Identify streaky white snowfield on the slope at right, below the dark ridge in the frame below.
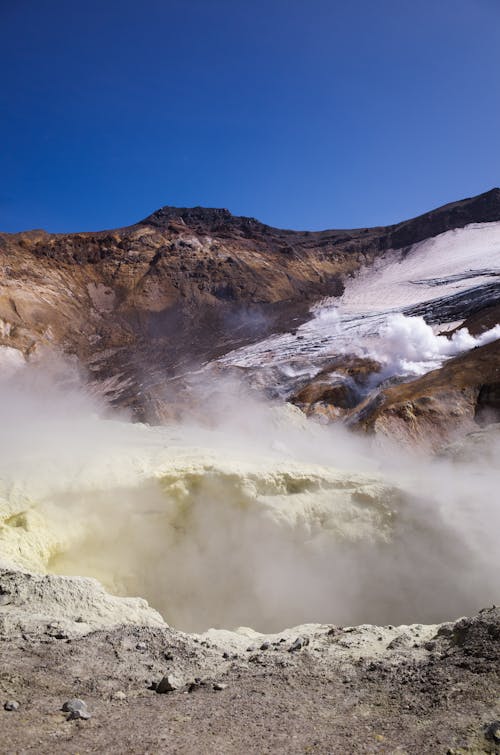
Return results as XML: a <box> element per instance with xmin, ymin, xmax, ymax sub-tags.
<box><xmin>211</xmin><ymin>222</ymin><xmax>500</xmax><ymax>378</ymax></box>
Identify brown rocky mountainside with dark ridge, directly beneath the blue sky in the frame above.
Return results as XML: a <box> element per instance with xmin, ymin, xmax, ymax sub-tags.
<box><xmin>0</xmin><ymin>189</ymin><xmax>500</xmax><ymax>420</ymax></box>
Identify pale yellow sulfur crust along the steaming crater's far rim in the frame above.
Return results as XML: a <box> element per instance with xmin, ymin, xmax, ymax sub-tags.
<box><xmin>0</xmin><ymin>449</ymin><xmax>398</xmax><ymax>573</ymax></box>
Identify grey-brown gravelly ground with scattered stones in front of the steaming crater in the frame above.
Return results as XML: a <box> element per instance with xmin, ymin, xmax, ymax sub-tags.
<box><xmin>0</xmin><ymin>568</ymin><xmax>500</xmax><ymax>755</ymax></box>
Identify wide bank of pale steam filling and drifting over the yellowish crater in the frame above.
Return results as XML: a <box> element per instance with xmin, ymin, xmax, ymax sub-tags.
<box><xmin>0</xmin><ymin>364</ymin><xmax>500</xmax><ymax>632</ymax></box>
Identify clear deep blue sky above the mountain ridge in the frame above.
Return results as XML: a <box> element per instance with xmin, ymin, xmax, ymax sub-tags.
<box><xmin>0</xmin><ymin>0</ymin><xmax>500</xmax><ymax>231</ymax></box>
